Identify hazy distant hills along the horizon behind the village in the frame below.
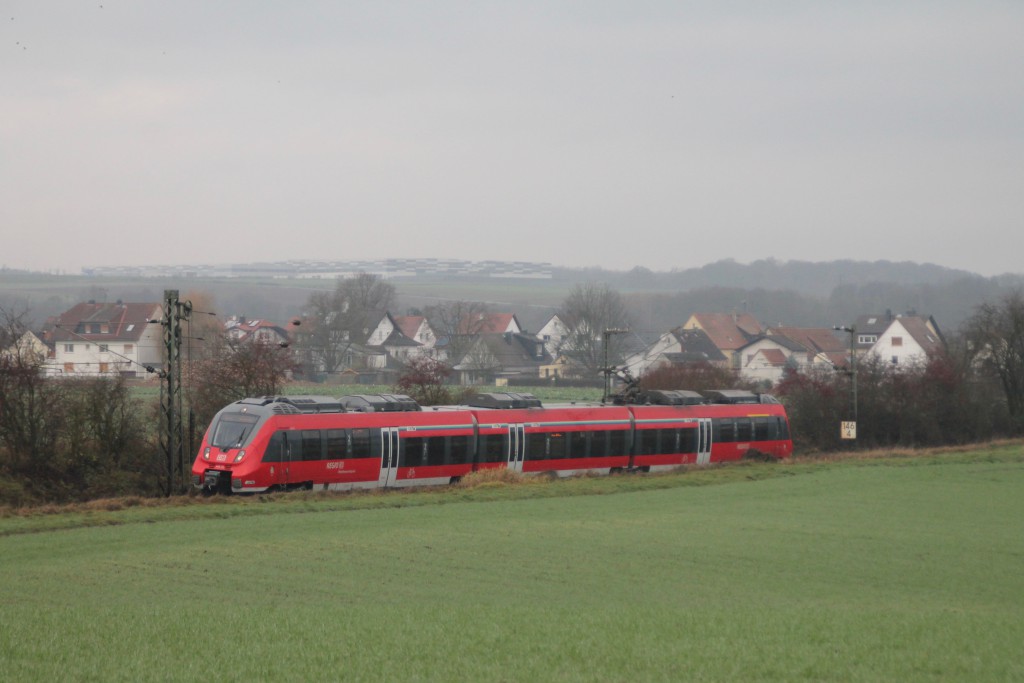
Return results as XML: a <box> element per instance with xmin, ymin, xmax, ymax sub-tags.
<box><xmin>0</xmin><ymin>259</ymin><xmax>1024</xmax><ymax>332</ymax></box>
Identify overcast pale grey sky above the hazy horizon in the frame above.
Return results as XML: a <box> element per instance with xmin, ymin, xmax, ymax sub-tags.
<box><xmin>6</xmin><ymin>0</ymin><xmax>1024</xmax><ymax>275</ymax></box>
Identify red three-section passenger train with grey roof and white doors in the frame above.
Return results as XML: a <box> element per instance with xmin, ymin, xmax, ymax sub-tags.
<box><xmin>193</xmin><ymin>391</ymin><xmax>793</xmax><ymax>493</ymax></box>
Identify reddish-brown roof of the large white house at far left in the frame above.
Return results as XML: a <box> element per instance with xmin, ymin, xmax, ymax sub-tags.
<box><xmin>52</xmin><ymin>302</ymin><xmax>163</xmax><ymax>344</ymax></box>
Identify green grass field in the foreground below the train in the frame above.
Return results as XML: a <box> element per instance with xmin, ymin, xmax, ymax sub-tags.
<box><xmin>0</xmin><ymin>443</ymin><xmax>1024</xmax><ymax>681</ymax></box>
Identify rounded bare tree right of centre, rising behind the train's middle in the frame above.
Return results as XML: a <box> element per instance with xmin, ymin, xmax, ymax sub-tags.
<box><xmin>558</xmin><ymin>283</ymin><xmax>630</xmax><ymax>375</ymax></box>
